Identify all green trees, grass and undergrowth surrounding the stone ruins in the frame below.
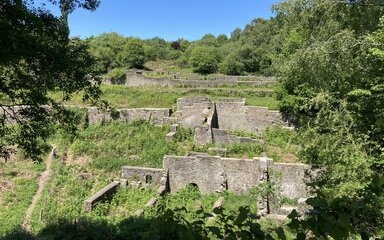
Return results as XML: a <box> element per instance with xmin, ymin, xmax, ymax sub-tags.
<box><xmin>0</xmin><ymin>0</ymin><xmax>384</xmax><ymax>239</ymax></box>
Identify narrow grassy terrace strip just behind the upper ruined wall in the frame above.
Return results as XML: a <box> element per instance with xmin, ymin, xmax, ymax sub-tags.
<box><xmin>50</xmin><ymin>85</ymin><xmax>278</xmax><ymax>109</ymax></box>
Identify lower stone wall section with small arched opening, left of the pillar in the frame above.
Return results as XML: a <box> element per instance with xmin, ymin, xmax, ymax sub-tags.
<box><xmin>163</xmin><ymin>156</ymin><xmax>259</xmax><ymax>193</ymax></box>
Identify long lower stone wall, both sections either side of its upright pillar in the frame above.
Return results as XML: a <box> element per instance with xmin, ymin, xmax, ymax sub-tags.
<box><xmin>163</xmin><ymin>155</ymin><xmax>310</xmax><ymax>200</ymax></box>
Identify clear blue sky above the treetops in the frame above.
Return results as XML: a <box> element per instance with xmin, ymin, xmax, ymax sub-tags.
<box><xmin>35</xmin><ymin>0</ymin><xmax>279</xmax><ymax>40</ymax></box>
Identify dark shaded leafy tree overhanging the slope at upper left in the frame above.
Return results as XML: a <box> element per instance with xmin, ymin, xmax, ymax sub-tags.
<box><xmin>0</xmin><ymin>0</ymin><xmax>101</xmax><ymax>160</ymax></box>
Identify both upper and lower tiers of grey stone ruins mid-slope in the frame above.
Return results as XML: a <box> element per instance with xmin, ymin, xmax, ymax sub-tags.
<box><xmin>83</xmin><ymin>97</ymin><xmax>310</xmax><ymax>215</ymax></box>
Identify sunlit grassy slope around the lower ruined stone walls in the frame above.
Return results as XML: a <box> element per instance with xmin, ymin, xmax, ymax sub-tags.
<box><xmin>0</xmin><ymin>122</ymin><xmax>294</xmax><ymax>238</ymax></box>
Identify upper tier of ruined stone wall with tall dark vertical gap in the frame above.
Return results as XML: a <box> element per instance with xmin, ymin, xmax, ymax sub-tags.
<box><xmin>88</xmin><ymin>97</ymin><xmax>290</xmax><ymax>145</ymax></box>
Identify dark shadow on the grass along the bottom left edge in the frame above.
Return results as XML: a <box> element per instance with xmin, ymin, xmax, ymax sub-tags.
<box><xmin>0</xmin><ymin>216</ymin><xmax>207</xmax><ymax>240</ymax></box>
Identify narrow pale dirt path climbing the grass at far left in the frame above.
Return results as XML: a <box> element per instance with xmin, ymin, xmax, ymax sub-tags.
<box><xmin>22</xmin><ymin>145</ymin><xmax>56</xmax><ymax>232</ymax></box>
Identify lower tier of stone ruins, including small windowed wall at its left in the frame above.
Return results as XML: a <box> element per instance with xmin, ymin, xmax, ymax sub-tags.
<box><xmin>122</xmin><ymin>154</ymin><xmax>310</xmax><ymax>214</ymax></box>
